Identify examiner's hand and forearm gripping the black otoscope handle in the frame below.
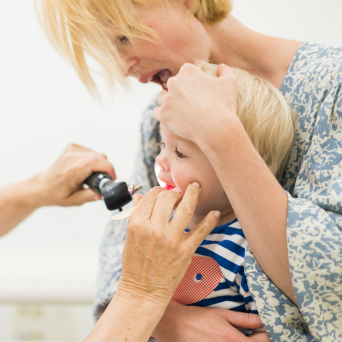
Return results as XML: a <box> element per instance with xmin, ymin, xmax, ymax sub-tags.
<box><xmin>0</xmin><ymin>145</ymin><xmax>115</xmax><ymax>236</ymax></box>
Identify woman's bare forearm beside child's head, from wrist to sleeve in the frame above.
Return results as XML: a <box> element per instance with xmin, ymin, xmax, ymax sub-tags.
<box><xmin>199</xmin><ymin>122</ymin><xmax>295</xmax><ymax>303</ymax></box>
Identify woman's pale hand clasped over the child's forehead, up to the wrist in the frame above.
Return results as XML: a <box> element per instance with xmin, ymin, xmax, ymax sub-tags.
<box><xmin>153</xmin><ymin>64</ymin><xmax>239</xmax><ymax>145</ymax></box>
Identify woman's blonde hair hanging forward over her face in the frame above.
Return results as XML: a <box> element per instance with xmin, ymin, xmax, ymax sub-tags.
<box><xmin>36</xmin><ymin>0</ymin><xmax>232</xmax><ymax>94</ymax></box>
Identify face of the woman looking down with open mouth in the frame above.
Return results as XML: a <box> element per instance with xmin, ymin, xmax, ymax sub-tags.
<box><xmin>116</xmin><ymin>0</ymin><xmax>211</xmax><ymax>88</ymax></box>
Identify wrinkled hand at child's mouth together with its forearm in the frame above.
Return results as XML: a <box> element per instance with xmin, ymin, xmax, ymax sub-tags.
<box><xmin>86</xmin><ymin>183</ymin><xmax>219</xmax><ymax>342</ymax></box>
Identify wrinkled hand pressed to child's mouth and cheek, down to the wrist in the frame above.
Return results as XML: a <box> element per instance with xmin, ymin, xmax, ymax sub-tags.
<box><xmin>116</xmin><ymin>183</ymin><xmax>219</xmax><ymax>308</ymax></box>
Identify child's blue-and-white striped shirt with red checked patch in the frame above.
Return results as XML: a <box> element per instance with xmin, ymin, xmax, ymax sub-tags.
<box><xmin>172</xmin><ymin>219</ymin><xmax>258</xmax><ymax>314</ymax></box>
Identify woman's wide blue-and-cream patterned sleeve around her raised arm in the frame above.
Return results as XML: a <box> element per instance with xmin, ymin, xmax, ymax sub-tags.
<box><xmin>287</xmin><ymin>195</ymin><xmax>342</xmax><ymax>341</ymax></box>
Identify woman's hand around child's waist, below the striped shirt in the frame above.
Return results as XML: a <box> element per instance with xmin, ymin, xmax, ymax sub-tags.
<box><xmin>152</xmin><ymin>300</ymin><xmax>267</xmax><ymax>342</ymax></box>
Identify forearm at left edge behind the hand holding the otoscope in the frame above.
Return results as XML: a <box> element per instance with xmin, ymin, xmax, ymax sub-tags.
<box><xmin>0</xmin><ymin>175</ymin><xmax>41</xmax><ymax>236</ymax></box>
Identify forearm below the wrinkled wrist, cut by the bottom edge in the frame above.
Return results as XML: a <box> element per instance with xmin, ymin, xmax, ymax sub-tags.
<box><xmin>85</xmin><ymin>290</ymin><xmax>167</xmax><ymax>342</ymax></box>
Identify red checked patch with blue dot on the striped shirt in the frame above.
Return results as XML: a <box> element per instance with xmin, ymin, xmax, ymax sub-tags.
<box><xmin>172</xmin><ymin>256</ymin><xmax>223</xmax><ymax>305</ymax></box>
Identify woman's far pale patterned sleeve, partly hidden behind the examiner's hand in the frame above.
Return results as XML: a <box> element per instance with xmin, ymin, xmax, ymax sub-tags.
<box><xmin>95</xmin><ymin>101</ymin><xmax>160</xmax><ymax>319</ymax></box>
